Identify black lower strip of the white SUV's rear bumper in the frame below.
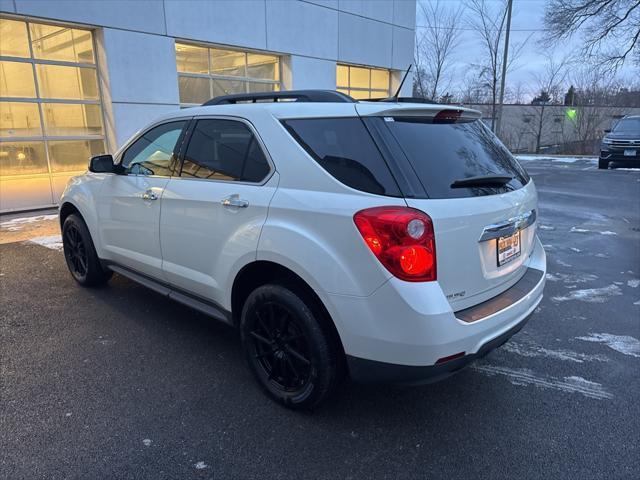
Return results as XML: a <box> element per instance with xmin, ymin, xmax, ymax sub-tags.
<box><xmin>347</xmin><ymin>315</ymin><xmax>532</xmax><ymax>385</ymax></box>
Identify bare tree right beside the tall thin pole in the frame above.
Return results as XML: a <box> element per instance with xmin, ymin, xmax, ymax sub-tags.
<box><xmin>466</xmin><ymin>0</ymin><xmax>528</xmax><ymax>131</ymax></box>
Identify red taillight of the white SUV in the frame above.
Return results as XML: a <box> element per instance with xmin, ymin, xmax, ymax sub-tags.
<box><xmin>353</xmin><ymin>207</ymin><xmax>437</xmax><ymax>282</ymax></box>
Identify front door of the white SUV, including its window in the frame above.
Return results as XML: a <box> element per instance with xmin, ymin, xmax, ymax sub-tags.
<box><xmin>98</xmin><ymin>120</ymin><xmax>187</xmax><ymax>279</ymax></box>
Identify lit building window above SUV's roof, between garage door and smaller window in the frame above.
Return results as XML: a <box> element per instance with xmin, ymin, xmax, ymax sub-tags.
<box><xmin>176</xmin><ymin>43</ymin><xmax>280</xmax><ymax>107</ymax></box>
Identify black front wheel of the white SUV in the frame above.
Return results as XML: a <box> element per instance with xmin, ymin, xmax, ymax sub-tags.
<box><xmin>62</xmin><ymin>214</ymin><xmax>113</xmax><ymax>287</ymax></box>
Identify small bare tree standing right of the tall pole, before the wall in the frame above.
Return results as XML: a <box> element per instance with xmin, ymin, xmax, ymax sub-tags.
<box><xmin>527</xmin><ymin>54</ymin><xmax>570</xmax><ymax>153</ymax></box>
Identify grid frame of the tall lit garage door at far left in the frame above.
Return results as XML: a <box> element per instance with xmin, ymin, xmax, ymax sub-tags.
<box><xmin>0</xmin><ymin>13</ymin><xmax>109</xmax><ymax>180</ymax></box>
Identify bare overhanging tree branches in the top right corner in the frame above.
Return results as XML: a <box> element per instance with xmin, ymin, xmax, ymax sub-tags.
<box><xmin>544</xmin><ymin>0</ymin><xmax>640</xmax><ymax>68</ymax></box>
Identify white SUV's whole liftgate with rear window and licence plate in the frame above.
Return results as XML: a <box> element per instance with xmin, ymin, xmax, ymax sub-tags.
<box><xmin>367</xmin><ymin>111</ymin><xmax>537</xmax><ymax>310</ymax></box>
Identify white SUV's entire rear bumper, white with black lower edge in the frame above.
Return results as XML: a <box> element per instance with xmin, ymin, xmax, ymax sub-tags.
<box><xmin>327</xmin><ymin>239</ymin><xmax>546</xmax><ymax>376</ymax></box>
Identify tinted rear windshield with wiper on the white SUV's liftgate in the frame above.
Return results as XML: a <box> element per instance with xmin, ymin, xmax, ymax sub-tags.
<box><xmin>380</xmin><ymin>117</ymin><xmax>529</xmax><ymax>198</ymax></box>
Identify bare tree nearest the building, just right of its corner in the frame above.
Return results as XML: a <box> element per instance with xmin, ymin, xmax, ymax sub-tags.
<box><xmin>416</xmin><ymin>0</ymin><xmax>463</xmax><ymax>100</ymax></box>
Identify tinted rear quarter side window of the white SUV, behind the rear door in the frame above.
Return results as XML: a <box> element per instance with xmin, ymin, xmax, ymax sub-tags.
<box><xmin>284</xmin><ymin>118</ymin><xmax>401</xmax><ymax>197</ymax></box>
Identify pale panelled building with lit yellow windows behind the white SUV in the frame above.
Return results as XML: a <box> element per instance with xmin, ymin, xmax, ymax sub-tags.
<box><xmin>0</xmin><ymin>0</ymin><xmax>416</xmax><ymax>212</ymax></box>
